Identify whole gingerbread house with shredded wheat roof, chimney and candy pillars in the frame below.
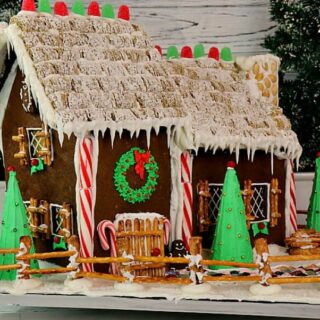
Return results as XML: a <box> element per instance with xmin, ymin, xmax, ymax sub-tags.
<box><xmin>1</xmin><ymin>8</ymin><xmax>301</xmax><ymax>268</ymax></box>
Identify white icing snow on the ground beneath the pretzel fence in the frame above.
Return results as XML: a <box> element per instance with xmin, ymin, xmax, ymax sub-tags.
<box><xmin>0</xmin><ymin>246</ymin><xmax>320</xmax><ymax>304</ymax></box>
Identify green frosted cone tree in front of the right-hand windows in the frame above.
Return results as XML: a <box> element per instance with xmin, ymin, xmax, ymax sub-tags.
<box><xmin>210</xmin><ymin>161</ymin><xmax>253</xmax><ymax>270</ymax></box>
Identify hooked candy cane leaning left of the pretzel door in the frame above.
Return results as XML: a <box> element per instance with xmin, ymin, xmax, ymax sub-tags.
<box><xmin>97</xmin><ymin>220</ymin><xmax>118</xmax><ymax>274</ymax></box>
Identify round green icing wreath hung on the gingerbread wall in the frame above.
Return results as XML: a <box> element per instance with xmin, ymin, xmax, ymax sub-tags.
<box><xmin>113</xmin><ymin>147</ymin><xmax>159</xmax><ymax>204</ymax></box>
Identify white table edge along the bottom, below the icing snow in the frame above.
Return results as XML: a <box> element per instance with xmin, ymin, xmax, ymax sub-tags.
<box><xmin>0</xmin><ymin>294</ymin><xmax>320</xmax><ymax>320</ymax></box>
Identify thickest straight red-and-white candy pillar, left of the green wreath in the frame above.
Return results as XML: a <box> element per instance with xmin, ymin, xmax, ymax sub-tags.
<box><xmin>79</xmin><ymin>137</ymin><xmax>94</xmax><ymax>272</ymax></box>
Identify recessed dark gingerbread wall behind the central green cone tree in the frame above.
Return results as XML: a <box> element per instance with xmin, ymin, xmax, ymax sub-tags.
<box><xmin>192</xmin><ymin>150</ymin><xmax>286</xmax><ymax>248</ymax></box>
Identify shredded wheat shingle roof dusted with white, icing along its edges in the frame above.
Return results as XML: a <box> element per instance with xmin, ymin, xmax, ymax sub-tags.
<box><xmin>8</xmin><ymin>14</ymin><xmax>301</xmax><ymax>158</ymax></box>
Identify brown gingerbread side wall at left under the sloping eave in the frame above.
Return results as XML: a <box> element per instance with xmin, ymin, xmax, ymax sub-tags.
<box><xmin>2</xmin><ymin>72</ymin><xmax>76</xmax><ymax>255</ymax></box>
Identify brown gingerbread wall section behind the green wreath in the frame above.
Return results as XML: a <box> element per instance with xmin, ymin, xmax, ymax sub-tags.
<box><xmin>95</xmin><ymin>130</ymin><xmax>171</xmax><ymax>271</ymax></box>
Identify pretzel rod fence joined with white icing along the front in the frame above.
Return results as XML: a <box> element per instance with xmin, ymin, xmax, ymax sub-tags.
<box><xmin>0</xmin><ymin>236</ymin><xmax>320</xmax><ymax>285</ymax></box>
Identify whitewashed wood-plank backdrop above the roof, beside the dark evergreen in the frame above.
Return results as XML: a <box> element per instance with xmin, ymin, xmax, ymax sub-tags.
<box><xmin>66</xmin><ymin>0</ymin><xmax>274</xmax><ymax>55</ymax></box>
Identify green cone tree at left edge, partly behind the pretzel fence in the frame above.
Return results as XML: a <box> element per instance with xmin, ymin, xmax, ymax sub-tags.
<box><xmin>0</xmin><ymin>168</ymin><xmax>39</xmax><ymax>280</ymax></box>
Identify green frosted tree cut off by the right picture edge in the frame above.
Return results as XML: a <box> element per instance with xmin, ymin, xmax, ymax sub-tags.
<box><xmin>307</xmin><ymin>152</ymin><xmax>320</xmax><ymax>232</ymax></box>
